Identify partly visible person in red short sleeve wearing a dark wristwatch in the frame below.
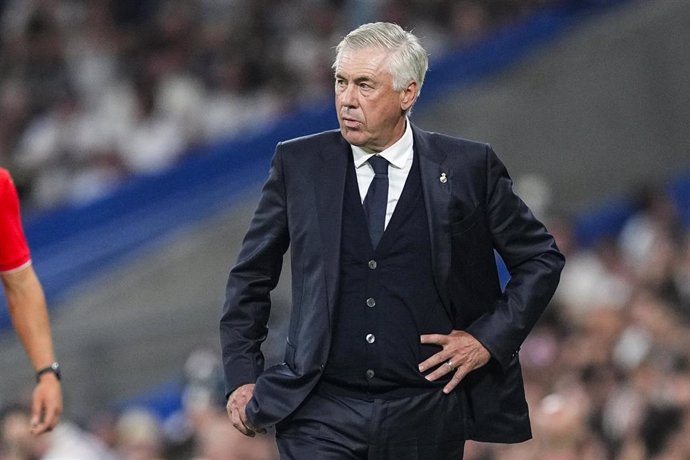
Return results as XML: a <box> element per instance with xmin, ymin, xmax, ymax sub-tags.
<box><xmin>0</xmin><ymin>168</ymin><xmax>62</xmax><ymax>434</ymax></box>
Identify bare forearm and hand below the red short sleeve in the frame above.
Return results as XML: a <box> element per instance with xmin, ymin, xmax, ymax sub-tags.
<box><xmin>0</xmin><ymin>265</ymin><xmax>62</xmax><ymax>434</ymax></box>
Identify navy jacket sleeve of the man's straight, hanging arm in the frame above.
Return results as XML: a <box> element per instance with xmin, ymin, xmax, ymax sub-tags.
<box><xmin>220</xmin><ymin>145</ymin><xmax>290</xmax><ymax>397</ymax></box>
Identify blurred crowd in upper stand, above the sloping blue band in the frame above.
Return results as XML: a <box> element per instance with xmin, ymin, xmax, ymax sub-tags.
<box><xmin>0</xmin><ymin>0</ymin><xmax>563</xmax><ymax>208</ymax></box>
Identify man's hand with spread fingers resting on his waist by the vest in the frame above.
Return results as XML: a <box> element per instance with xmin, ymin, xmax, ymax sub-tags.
<box><xmin>419</xmin><ymin>330</ymin><xmax>491</xmax><ymax>394</ymax></box>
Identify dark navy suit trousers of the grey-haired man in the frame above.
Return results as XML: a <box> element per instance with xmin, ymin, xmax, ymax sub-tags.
<box><xmin>276</xmin><ymin>386</ymin><xmax>465</xmax><ymax>460</ymax></box>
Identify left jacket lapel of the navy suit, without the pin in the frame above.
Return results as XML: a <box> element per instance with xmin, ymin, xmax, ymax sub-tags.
<box><xmin>311</xmin><ymin>136</ymin><xmax>351</xmax><ymax>318</ymax></box>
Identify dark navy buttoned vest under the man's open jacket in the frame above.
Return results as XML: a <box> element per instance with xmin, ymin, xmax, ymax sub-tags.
<box><xmin>320</xmin><ymin>154</ymin><xmax>452</xmax><ymax>398</ymax></box>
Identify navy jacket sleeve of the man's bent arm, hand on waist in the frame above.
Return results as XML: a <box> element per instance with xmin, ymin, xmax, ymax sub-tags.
<box><xmin>467</xmin><ymin>146</ymin><xmax>565</xmax><ymax>368</ymax></box>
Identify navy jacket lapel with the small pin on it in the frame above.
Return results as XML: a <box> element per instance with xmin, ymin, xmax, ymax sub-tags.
<box><xmin>412</xmin><ymin>125</ymin><xmax>453</xmax><ymax>319</ymax></box>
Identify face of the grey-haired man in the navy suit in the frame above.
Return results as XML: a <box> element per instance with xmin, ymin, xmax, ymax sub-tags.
<box><xmin>335</xmin><ymin>48</ymin><xmax>417</xmax><ymax>152</ymax></box>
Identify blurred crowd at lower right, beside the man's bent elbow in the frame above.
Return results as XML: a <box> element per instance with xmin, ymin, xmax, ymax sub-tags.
<box><xmin>475</xmin><ymin>186</ymin><xmax>690</xmax><ymax>460</ymax></box>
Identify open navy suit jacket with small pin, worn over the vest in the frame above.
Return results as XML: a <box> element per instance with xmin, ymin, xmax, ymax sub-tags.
<box><xmin>220</xmin><ymin>126</ymin><xmax>564</xmax><ymax>442</ymax></box>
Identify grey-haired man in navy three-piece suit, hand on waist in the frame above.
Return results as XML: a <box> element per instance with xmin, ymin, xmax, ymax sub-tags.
<box><xmin>220</xmin><ymin>23</ymin><xmax>564</xmax><ymax>459</ymax></box>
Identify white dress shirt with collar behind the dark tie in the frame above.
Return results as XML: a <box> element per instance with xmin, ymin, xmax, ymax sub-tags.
<box><xmin>350</xmin><ymin>120</ymin><xmax>413</xmax><ymax>229</ymax></box>
